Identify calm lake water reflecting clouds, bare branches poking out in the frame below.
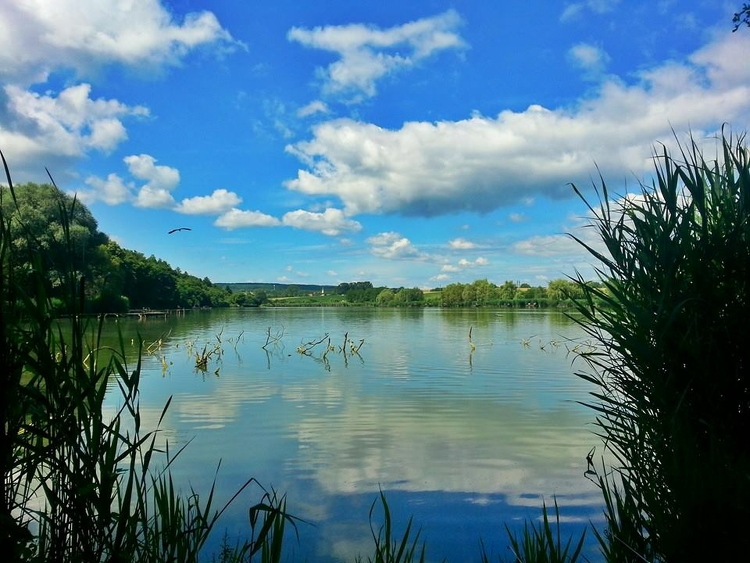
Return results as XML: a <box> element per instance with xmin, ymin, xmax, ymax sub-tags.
<box><xmin>101</xmin><ymin>307</ymin><xmax>603</xmax><ymax>563</ymax></box>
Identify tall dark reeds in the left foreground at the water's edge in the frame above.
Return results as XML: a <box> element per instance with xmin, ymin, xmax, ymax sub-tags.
<box><xmin>0</xmin><ymin>153</ymin><xmax>294</xmax><ymax>562</ymax></box>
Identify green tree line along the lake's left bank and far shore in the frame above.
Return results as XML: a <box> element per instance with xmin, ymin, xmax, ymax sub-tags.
<box><xmin>0</xmin><ymin>183</ymin><xmax>604</xmax><ymax>314</ymax></box>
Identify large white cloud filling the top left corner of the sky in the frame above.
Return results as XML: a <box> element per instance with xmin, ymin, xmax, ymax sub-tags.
<box><xmin>0</xmin><ymin>0</ymin><xmax>242</xmax><ymax>85</ymax></box>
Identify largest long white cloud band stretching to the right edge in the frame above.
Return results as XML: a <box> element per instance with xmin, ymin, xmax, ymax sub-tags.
<box><xmin>285</xmin><ymin>34</ymin><xmax>750</xmax><ymax>217</ymax></box>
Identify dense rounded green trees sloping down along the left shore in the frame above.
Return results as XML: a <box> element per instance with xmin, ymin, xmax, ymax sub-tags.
<box><xmin>0</xmin><ymin>183</ymin><xmax>229</xmax><ymax>313</ymax></box>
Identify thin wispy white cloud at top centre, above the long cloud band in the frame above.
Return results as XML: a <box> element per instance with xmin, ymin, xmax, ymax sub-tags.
<box><xmin>287</xmin><ymin>10</ymin><xmax>465</xmax><ymax>101</ymax></box>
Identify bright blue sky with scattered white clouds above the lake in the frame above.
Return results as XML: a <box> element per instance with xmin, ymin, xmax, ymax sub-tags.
<box><xmin>0</xmin><ymin>0</ymin><xmax>750</xmax><ymax>288</ymax></box>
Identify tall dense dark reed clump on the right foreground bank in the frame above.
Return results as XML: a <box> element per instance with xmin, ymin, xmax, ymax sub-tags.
<box><xmin>577</xmin><ymin>131</ymin><xmax>750</xmax><ymax>561</ymax></box>
